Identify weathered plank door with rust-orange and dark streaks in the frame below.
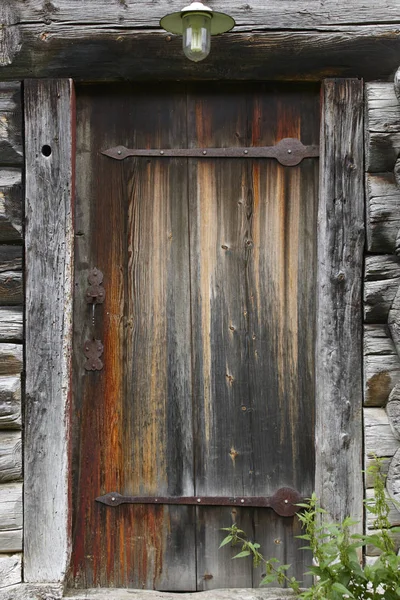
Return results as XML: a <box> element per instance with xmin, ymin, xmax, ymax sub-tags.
<box><xmin>70</xmin><ymin>83</ymin><xmax>319</xmax><ymax>591</ymax></box>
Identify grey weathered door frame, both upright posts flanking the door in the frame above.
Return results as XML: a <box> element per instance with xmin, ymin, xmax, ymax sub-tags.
<box><xmin>21</xmin><ymin>79</ymin><xmax>364</xmax><ymax>598</ymax></box>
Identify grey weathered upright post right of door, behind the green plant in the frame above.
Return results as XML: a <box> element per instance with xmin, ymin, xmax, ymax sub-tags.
<box><xmin>315</xmin><ymin>79</ymin><xmax>364</xmax><ymax>527</ymax></box>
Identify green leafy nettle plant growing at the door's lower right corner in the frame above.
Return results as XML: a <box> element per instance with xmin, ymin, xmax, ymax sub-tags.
<box><xmin>220</xmin><ymin>459</ymin><xmax>400</xmax><ymax>600</ymax></box>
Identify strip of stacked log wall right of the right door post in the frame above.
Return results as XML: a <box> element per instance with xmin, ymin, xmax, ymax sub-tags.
<box><xmin>364</xmin><ymin>82</ymin><xmax>400</xmax><ymax>560</ymax></box>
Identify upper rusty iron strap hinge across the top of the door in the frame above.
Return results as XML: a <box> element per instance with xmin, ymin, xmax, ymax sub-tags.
<box><xmin>102</xmin><ymin>138</ymin><xmax>319</xmax><ymax>167</ymax></box>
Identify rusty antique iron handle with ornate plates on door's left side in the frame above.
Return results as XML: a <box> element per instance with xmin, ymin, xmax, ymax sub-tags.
<box><xmin>84</xmin><ymin>268</ymin><xmax>106</xmax><ymax>371</ymax></box>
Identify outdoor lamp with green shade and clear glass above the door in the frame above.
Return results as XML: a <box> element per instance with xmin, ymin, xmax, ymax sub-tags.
<box><xmin>160</xmin><ymin>2</ymin><xmax>235</xmax><ymax>62</ymax></box>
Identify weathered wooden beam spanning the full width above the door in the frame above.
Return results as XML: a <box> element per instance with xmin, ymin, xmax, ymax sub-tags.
<box><xmin>0</xmin><ymin>0</ymin><xmax>400</xmax><ymax>81</ymax></box>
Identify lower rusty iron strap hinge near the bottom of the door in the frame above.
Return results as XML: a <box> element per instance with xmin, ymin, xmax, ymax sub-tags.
<box><xmin>96</xmin><ymin>487</ymin><xmax>303</xmax><ymax>517</ymax></box>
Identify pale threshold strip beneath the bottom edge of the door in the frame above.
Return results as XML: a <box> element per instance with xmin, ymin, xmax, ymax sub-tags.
<box><xmin>64</xmin><ymin>588</ymin><xmax>295</xmax><ymax>600</ymax></box>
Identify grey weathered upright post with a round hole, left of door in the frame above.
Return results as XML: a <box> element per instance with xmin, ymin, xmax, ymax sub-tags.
<box><xmin>24</xmin><ymin>80</ymin><xmax>74</xmax><ymax>582</ymax></box>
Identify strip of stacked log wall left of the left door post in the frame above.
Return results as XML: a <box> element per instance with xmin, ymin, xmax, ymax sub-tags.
<box><xmin>0</xmin><ymin>83</ymin><xmax>23</xmax><ymax>588</ymax></box>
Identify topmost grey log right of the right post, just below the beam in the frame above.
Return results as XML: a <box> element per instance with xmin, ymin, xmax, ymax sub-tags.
<box><xmin>365</xmin><ymin>81</ymin><xmax>400</xmax><ymax>133</ymax></box>
